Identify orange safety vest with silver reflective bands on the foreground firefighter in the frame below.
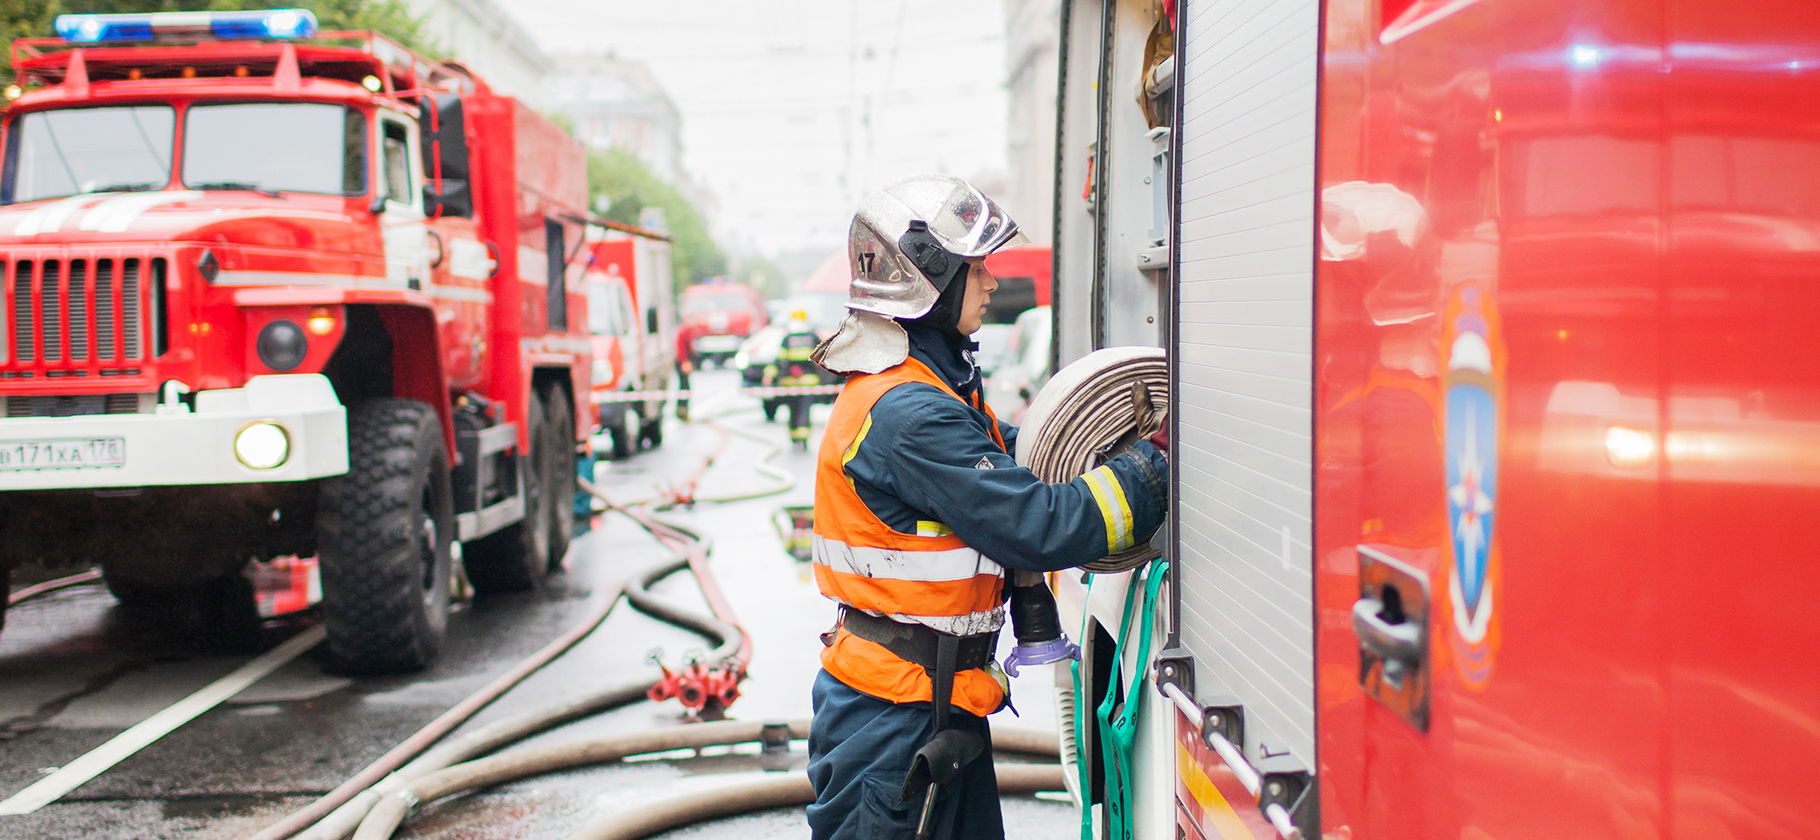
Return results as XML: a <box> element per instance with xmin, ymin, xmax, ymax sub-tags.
<box><xmin>814</xmin><ymin>358</ymin><xmax>1006</xmax><ymax>716</ymax></box>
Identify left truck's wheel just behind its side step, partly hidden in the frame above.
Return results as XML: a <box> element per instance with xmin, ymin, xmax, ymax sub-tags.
<box><xmin>462</xmin><ymin>391</ymin><xmax>549</xmax><ymax>595</ymax></box>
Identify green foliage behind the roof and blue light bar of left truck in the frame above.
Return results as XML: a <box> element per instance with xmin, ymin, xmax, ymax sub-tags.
<box><xmin>0</xmin><ymin>0</ymin><xmax>435</xmax><ymax>84</ymax></box>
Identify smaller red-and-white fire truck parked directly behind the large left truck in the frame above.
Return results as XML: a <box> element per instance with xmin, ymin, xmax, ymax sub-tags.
<box><xmin>586</xmin><ymin>225</ymin><xmax>677</xmax><ymax>458</ymax></box>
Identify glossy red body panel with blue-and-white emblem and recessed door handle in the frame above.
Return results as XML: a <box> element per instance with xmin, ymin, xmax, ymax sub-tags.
<box><xmin>1314</xmin><ymin>0</ymin><xmax>1820</xmax><ymax>840</ymax></box>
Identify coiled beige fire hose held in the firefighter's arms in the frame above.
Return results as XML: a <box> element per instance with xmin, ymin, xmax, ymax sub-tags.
<box><xmin>1017</xmin><ymin>347</ymin><xmax>1168</xmax><ymax>575</ymax></box>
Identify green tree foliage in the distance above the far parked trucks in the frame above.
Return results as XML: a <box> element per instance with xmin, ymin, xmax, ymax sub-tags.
<box><xmin>588</xmin><ymin>149</ymin><xmax>726</xmax><ymax>292</ymax></box>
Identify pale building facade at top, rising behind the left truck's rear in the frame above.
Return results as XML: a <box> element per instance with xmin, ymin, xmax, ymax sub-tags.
<box><xmin>406</xmin><ymin>0</ymin><xmax>550</xmax><ymax>109</ymax></box>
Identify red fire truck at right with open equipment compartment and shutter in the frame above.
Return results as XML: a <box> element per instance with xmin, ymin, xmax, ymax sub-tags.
<box><xmin>1054</xmin><ymin>0</ymin><xmax>1820</xmax><ymax>840</ymax></box>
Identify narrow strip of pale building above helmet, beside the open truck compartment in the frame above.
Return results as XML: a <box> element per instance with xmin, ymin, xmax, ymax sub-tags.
<box><xmin>988</xmin><ymin>0</ymin><xmax>1061</xmax><ymax>245</ymax></box>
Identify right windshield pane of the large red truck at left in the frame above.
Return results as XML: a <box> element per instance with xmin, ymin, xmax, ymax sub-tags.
<box><xmin>184</xmin><ymin>102</ymin><xmax>366</xmax><ymax>195</ymax></box>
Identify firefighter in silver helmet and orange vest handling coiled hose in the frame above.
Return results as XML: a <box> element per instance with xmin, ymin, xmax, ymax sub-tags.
<box><xmin>808</xmin><ymin>175</ymin><xmax>1168</xmax><ymax>840</ymax></box>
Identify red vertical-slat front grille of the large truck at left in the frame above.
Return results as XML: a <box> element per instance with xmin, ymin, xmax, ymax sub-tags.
<box><xmin>0</xmin><ymin>253</ymin><xmax>166</xmax><ymax>378</ymax></box>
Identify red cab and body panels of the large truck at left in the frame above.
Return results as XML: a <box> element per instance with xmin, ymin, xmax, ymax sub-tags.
<box><xmin>0</xmin><ymin>33</ymin><xmax>590</xmax><ymax>456</ymax></box>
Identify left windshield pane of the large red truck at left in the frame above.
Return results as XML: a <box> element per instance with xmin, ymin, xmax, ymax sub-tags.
<box><xmin>0</xmin><ymin>105</ymin><xmax>177</xmax><ymax>204</ymax></box>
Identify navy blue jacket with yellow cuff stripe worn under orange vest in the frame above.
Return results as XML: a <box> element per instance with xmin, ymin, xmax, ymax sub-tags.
<box><xmin>846</xmin><ymin>325</ymin><xmax>1168</xmax><ymax>571</ymax></box>
